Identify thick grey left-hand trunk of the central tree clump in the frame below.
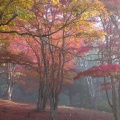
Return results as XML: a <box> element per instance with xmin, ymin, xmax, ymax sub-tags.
<box><xmin>37</xmin><ymin>42</ymin><xmax>49</xmax><ymax>112</ymax></box>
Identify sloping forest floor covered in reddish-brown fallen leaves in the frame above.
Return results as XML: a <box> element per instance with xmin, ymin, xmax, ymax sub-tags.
<box><xmin>0</xmin><ymin>99</ymin><xmax>114</xmax><ymax>120</ymax></box>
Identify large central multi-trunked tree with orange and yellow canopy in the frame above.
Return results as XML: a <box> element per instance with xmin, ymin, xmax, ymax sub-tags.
<box><xmin>0</xmin><ymin>0</ymin><xmax>106</xmax><ymax>120</ymax></box>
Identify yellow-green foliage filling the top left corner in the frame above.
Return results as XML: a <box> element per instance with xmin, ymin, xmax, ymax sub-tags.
<box><xmin>0</xmin><ymin>0</ymin><xmax>34</xmax><ymax>27</ymax></box>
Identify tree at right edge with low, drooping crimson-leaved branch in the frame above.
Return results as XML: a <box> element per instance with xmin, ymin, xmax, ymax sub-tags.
<box><xmin>75</xmin><ymin>0</ymin><xmax>120</xmax><ymax>120</ymax></box>
